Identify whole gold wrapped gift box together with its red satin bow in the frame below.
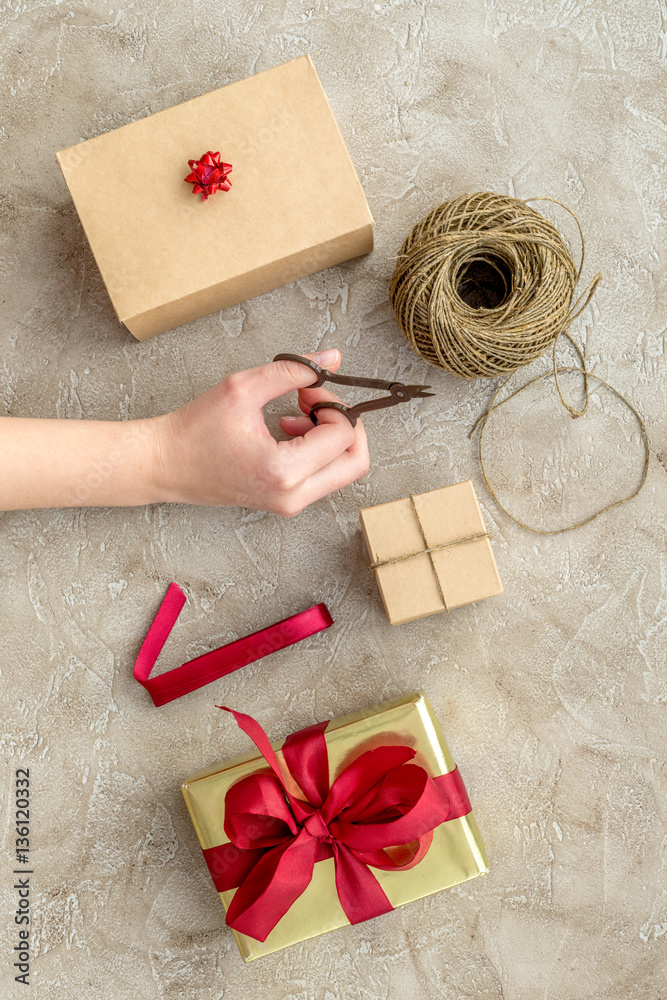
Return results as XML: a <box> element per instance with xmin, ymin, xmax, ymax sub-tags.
<box><xmin>183</xmin><ymin>692</ymin><xmax>488</xmax><ymax>961</ymax></box>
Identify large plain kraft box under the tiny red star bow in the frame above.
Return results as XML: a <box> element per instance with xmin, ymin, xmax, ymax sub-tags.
<box><xmin>56</xmin><ymin>56</ymin><xmax>373</xmax><ymax>340</ymax></box>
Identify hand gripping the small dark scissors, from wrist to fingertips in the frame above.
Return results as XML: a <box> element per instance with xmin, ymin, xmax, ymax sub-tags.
<box><xmin>155</xmin><ymin>350</ymin><xmax>369</xmax><ymax>517</ymax></box>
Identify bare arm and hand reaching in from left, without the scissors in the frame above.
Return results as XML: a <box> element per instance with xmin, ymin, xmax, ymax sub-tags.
<box><xmin>0</xmin><ymin>349</ymin><xmax>369</xmax><ymax>517</ymax></box>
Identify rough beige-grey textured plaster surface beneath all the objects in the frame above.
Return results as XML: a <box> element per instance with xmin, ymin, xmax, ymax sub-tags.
<box><xmin>0</xmin><ymin>0</ymin><xmax>667</xmax><ymax>1000</ymax></box>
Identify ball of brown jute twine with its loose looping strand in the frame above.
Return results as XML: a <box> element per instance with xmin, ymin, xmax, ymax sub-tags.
<box><xmin>389</xmin><ymin>191</ymin><xmax>649</xmax><ymax>535</ymax></box>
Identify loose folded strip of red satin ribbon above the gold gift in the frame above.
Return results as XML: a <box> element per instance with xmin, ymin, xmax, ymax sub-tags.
<box><xmin>134</xmin><ymin>583</ymin><xmax>333</xmax><ymax>706</ymax></box>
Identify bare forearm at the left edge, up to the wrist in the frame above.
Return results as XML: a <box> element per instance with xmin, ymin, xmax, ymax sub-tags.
<box><xmin>0</xmin><ymin>417</ymin><xmax>162</xmax><ymax>510</ymax></box>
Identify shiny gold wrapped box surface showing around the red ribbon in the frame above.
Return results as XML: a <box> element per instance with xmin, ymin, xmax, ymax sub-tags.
<box><xmin>182</xmin><ymin>692</ymin><xmax>488</xmax><ymax>961</ymax></box>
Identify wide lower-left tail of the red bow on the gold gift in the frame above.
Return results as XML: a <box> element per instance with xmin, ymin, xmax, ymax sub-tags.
<box><xmin>227</xmin><ymin>831</ymin><xmax>320</xmax><ymax>941</ymax></box>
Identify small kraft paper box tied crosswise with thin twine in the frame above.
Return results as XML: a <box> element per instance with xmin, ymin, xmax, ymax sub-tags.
<box><xmin>359</xmin><ymin>481</ymin><xmax>503</xmax><ymax>625</ymax></box>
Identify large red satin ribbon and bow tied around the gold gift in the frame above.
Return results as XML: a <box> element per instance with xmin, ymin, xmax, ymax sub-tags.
<box><xmin>203</xmin><ymin>706</ymin><xmax>471</xmax><ymax>941</ymax></box>
